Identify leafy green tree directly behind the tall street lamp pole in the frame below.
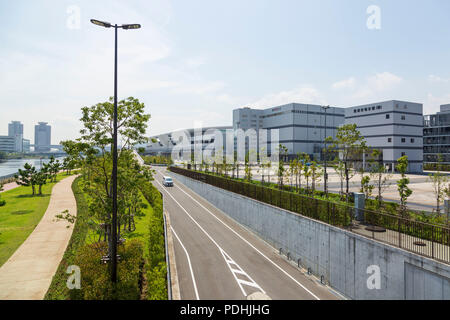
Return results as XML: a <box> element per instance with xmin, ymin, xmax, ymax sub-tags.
<box><xmin>76</xmin><ymin>97</ymin><xmax>151</xmax><ymax>255</ymax></box>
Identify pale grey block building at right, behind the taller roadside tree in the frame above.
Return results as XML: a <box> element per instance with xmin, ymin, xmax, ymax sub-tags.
<box><xmin>345</xmin><ymin>100</ymin><xmax>423</xmax><ymax>172</ymax></box>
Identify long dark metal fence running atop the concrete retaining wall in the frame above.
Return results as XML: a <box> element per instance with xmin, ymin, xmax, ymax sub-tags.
<box><xmin>170</xmin><ymin>167</ymin><xmax>450</xmax><ymax>264</ymax></box>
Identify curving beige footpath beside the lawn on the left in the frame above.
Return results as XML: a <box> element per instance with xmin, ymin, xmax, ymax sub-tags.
<box><xmin>0</xmin><ymin>176</ymin><xmax>77</xmax><ymax>300</ymax></box>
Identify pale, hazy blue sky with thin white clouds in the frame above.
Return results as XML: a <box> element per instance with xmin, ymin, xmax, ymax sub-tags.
<box><xmin>0</xmin><ymin>0</ymin><xmax>450</xmax><ymax>143</ymax></box>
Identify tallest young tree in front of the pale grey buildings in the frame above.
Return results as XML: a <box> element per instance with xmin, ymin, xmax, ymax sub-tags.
<box><xmin>332</xmin><ymin>124</ymin><xmax>366</xmax><ymax>200</ymax></box>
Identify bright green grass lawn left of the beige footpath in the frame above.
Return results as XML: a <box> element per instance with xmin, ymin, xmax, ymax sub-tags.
<box><xmin>0</xmin><ymin>173</ymin><xmax>71</xmax><ymax>266</ymax></box>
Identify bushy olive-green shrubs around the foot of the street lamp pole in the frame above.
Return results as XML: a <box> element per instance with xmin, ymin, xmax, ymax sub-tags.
<box><xmin>70</xmin><ymin>240</ymin><xmax>143</xmax><ymax>300</ymax></box>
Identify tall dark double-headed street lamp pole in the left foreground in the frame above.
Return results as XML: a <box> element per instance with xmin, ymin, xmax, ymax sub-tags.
<box><xmin>91</xmin><ymin>19</ymin><xmax>141</xmax><ymax>282</ymax></box>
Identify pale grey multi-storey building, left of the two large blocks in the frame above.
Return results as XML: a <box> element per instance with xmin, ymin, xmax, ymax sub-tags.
<box><xmin>233</xmin><ymin>103</ymin><xmax>345</xmax><ymax>160</ymax></box>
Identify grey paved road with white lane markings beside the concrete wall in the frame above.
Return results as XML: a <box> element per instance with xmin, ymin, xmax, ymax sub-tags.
<box><xmin>154</xmin><ymin>168</ymin><xmax>342</xmax><ymax>300</ymax></box>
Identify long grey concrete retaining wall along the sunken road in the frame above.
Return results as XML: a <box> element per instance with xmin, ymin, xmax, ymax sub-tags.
<box><xmin>171</xmin><ymin>173</ymin><xmax>450</xmax><ymax>300</ymax></box>
